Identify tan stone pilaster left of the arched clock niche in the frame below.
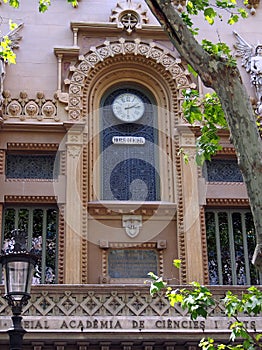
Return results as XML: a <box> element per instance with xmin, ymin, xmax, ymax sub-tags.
<box><xmin>64</xmin><ymin>125</ymin><xmax>83</xmax><ymax>284</ymax></box>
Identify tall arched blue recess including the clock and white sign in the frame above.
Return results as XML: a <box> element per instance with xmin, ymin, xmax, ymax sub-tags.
<box><xmin>100</xmin><ymin>85</ymin><xmax>160</xmax><ymax>201</ymax></box>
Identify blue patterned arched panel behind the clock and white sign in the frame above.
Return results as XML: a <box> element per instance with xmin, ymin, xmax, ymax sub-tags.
<box><xmin>100</xmin><ymin>89</ymin><xmax>160</xmax><ymax>201</ymax></box>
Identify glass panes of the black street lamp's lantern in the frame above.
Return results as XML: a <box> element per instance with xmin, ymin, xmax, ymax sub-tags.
<box><xmin>5</xmin><ymin>261</ymin><xmax>33</xmax><ymax>300</ymax></box>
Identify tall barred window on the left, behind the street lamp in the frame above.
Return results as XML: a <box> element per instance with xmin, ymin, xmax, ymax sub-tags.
<box><xmin>2</xmin><ymin>207</ymin><xmax>58</xmax><ymax>284</ymax></box>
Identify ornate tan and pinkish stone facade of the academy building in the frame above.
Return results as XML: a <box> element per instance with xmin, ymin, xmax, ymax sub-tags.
<box><xmin>0</xmin><ymin>0</ymin><xmax>262</xmax><ymax>350</ymax></box>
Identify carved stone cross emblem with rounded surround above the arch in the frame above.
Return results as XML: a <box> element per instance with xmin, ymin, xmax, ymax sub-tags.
<box><xmin>110</xmin><ymin>0</ymin><xmax>148</xmax><ymax>34</ymax></box>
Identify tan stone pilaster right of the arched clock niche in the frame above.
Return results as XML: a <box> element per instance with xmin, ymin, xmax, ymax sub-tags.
<box><xmin>180</xmin><ymin>127</ymin><xmax>204</xmax><ymax>283</ymax></box>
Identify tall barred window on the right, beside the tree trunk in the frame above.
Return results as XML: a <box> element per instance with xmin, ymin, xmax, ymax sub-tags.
<box><xmin>206</xmin><ymin>209</ymin><xmax>262</xmax><ymax>285</ymax></box>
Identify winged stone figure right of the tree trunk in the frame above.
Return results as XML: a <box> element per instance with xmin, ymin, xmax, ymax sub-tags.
<box><xmin>234</xmin><ymin>32</ymin><xmax>262</xmax><ymax>115</ymax></box>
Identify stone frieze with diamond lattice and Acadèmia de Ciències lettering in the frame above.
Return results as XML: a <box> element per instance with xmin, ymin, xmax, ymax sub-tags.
<box><xmin>0</xmin><ymin>285</ymin><xmax>262</xmax><ymax>334</ymax></box>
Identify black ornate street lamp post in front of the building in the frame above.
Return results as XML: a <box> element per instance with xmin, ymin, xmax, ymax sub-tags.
<box><xmin>0</xmin><ymin>230</ymin><xmax>38</xmax><ymax>350</ymax></box>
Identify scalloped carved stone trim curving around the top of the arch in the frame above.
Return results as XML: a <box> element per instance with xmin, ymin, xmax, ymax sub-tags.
<box><xmin>65</xmin><ymin>38</ymin><xmax>192</xmax><ymax>121</ymax></box>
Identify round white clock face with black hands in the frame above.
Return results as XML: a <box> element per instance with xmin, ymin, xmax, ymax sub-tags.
<box><xmin>112</xmin><ymin>92</ymin><xmax>145</xmax><ymax>123</ymax></box>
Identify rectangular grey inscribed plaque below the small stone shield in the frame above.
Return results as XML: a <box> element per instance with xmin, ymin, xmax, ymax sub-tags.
<box><xmin>108</xmin><ymin>249</ymin><xmax>158</xmax><ymax>278</ymax></box>
